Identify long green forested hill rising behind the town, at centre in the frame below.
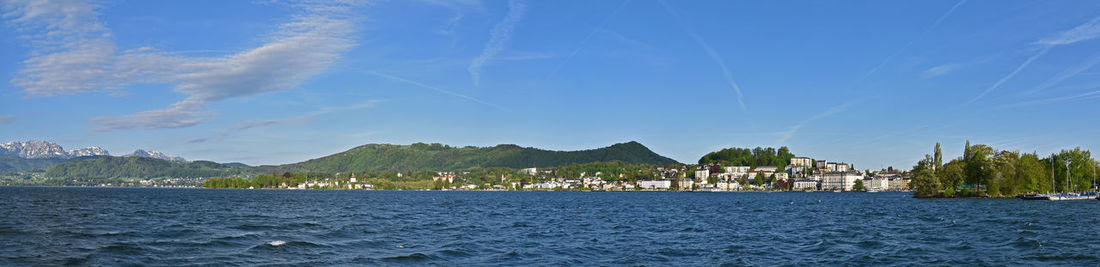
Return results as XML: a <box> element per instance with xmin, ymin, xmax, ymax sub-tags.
<box><xmin>260</xmin><ymin>142</ymin><xmax>677</xmax><ymax>173</ymax></box>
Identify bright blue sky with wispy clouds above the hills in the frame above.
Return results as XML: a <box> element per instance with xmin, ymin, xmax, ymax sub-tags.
<box><xmin>0</xmin><ymin>0</ymin><xmax>1100</xmax><ymax>168</ymax></box>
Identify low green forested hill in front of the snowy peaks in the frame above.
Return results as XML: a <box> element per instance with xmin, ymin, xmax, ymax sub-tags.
<box><xmin>45</xmin><ymin>156</ymin><xmax>251</xmax><ymax>178</ymax></box>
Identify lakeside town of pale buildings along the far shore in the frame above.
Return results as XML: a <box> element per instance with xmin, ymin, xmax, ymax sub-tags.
<box><xmin>249</xmin><ymin>157</ymin><xmax>911</xmax><ymax>192</ymax></box>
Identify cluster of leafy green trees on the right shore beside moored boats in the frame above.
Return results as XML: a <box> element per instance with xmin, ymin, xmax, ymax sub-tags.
<box><xmin>911</xmin><ymin>141</ymin><xmax>1098</xmax><ymax>198</ymax></box>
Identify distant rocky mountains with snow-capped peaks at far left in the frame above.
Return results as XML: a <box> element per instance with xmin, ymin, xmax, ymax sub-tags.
<box><xmin>0</xmin><ymin>141</ymin><xmax>186</xmax><ymax>174</ymax></box>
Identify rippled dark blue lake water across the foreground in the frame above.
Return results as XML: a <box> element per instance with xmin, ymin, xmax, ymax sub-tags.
<box><xmin>0</xmin><ymin>187</ymin><xmax>1100</xmax><ymax>266</ymax></box>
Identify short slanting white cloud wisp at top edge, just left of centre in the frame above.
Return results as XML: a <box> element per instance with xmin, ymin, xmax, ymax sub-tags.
<box><xmin>466</xmin><ymin>0</ymin><xmax>527</xmax><ymax>86</ymax></box>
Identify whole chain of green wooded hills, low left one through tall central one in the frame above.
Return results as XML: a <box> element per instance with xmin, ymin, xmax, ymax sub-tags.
<box><xmin>19</xmin><ymin>142</ymin><xmax>679</xmax><ymax>178</ymax></box>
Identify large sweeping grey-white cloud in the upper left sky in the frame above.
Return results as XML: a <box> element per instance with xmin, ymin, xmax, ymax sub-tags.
<box><xmin>4</xmin><ymin>0</ymin><xmax>360</xmax><ymax>131</ymax></box>
